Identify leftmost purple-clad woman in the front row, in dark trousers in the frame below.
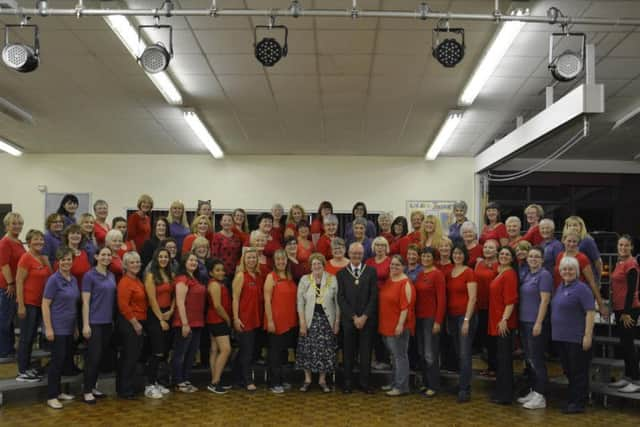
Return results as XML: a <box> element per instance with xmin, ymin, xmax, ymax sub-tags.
<box><xmin>42</xmin><ymin>246</ymin><xmax>80</xmax><ymax>409</ymax></box>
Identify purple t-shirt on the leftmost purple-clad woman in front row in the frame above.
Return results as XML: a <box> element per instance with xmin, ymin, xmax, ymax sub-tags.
<box><xmin>43</xmin><ymin>271</ymin><xmax>80</xmax><ymax>335</ymax></box>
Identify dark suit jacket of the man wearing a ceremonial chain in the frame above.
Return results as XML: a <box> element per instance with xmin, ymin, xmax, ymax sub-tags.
<box><xmin>336</xmin><ymin>263</ymin><xmax>378</xmax><ymax>322</ymax></box>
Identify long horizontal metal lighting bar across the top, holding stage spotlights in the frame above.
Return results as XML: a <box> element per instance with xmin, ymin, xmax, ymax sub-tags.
<box><xmin>0</xmin><ymin>7</ymin><xmax>640</xmax><ymax>26</ymax></box>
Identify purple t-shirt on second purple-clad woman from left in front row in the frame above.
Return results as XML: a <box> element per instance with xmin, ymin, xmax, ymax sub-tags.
<box><xmin>82</xmin><ymin>268</ymin><xmax>116</xmax><ymax>325</ymax></box>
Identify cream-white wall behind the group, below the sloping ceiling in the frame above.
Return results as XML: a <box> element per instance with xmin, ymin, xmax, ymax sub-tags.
<box><xmin>0</xmin><ymin>154</ymin><xmax>475</xmax><ymax>234</ymax></box>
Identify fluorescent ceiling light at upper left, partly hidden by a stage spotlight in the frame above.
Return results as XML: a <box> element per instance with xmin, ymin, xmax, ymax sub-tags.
<box><xmin>104</xmin><ymin>15</ymin><xmax>182</xmax><ymax>105</ymax></box>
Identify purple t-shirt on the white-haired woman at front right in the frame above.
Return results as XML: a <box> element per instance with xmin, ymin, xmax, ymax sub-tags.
<box><xmin>551</xmin><ymin>280</ymin><xmax>596</xmax><ymax>344</ymax></box>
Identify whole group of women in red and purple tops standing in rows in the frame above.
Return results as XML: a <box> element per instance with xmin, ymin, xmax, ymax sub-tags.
<box><xmin>0</xmin><ymin>195</ymin><xmax>640</xmax><ymax>413</ymax></box>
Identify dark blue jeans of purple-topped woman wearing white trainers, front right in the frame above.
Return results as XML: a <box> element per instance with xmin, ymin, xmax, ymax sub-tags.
<box><xmin>520</xmin><ymin>322</ymin><xmax>549</xmax><ymax>395</ymax></box>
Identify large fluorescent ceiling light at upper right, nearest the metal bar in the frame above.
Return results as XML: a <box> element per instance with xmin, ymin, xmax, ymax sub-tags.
<box><xmin>458</xmin><ymin>10</ymin><xmax>526</xmax><ymax>106</ymax></box>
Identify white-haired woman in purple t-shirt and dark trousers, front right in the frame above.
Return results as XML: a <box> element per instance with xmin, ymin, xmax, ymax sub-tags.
<box><xmin>551</xmin><ymin>256</ymin><xmax>596</xmax><ymax>414</ymax></box>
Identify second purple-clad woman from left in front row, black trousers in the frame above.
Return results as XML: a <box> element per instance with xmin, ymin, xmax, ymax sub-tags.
<box><xmin>82</xmin><ymin>246</ymin><xmax>116</xmax><ymax>404</ymax></box>
